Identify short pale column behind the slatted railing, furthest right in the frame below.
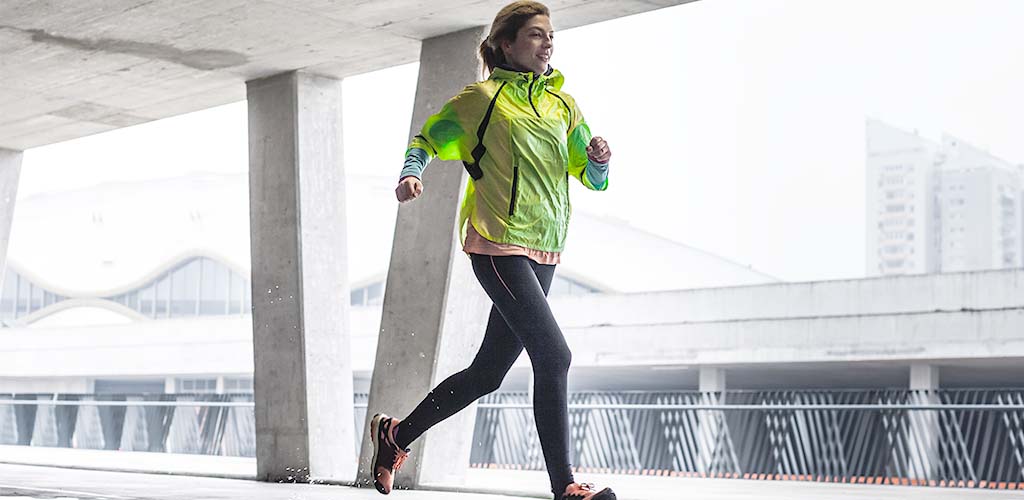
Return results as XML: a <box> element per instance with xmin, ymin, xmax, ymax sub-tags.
<box><xmin>906</xmin><ymin>363</ymin><xmax>942</xmax><ymax>480</ymax></box>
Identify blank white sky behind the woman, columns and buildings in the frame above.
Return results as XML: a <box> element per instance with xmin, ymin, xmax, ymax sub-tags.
<box><xmin>15</xmin><ymin>0</ymin><xmax>1024</xmax><ymax>281</ymax></box>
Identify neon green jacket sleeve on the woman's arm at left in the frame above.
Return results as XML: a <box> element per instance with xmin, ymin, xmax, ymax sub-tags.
<box><xmin>406</xmin><ymin>84</ymin><xmax>487</xmax><ymax>163</ymax></box>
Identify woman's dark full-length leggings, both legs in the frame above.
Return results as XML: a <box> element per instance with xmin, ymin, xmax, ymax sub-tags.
<box><xmin>396</xmin><ymin>254</ymin><xmax>573</xmax><ymax>498</ymax></box>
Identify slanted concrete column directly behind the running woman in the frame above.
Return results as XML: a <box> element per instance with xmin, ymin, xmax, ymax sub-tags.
<box><xmin>359</xmin><ymin>28</ymin><xmax>489</xmax><ymax>488</ymax></box>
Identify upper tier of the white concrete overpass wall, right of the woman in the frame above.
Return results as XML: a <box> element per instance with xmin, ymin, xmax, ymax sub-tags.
<box><xmin>552</xmin><ymin>268</ymin><xmax>1024</xmax><ymax>329</ymax></box>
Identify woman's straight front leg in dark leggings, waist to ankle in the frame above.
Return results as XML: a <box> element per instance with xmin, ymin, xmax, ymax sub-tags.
<box><xmin>471</xmin><ymin>255</ymin><xmax>573</xmax><ymax>498</ymax></box>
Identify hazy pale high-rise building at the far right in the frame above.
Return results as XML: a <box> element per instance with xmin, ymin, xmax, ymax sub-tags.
<box><xmin>865</xmin><ymin>120</ymin><xmax>1024</xmax><ymax>276</ymax></box>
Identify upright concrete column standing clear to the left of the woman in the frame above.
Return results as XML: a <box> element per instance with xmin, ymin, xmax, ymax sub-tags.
<box><xmin>247</xmin><ymin>72</ymin><xmax>355</xmax><ymax>482</ymax></box>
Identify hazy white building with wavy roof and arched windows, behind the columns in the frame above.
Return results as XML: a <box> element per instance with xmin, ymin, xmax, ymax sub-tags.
<box><xmin>0</xmin><ymin>174</ymin><xmax>778</xmax><ymax>393</ymax></box>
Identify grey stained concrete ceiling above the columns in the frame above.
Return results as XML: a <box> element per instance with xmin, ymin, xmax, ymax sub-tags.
<box><xmin>0</xmin><ymin>0</ymin><xmax>693</xmax><ymax>150</ymax></box>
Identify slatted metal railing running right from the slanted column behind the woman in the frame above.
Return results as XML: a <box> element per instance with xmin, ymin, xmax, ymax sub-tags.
<box><xmin>471</xmin><ymin>389</ymin><xmax>1024</xmax><ymax>488</ymax></box>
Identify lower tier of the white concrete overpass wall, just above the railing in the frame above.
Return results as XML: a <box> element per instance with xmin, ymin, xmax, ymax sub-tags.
<box><xmin>564</xmin><ymin>307</ymin><xmax>1024</xmax><ymax>367</ymax></box>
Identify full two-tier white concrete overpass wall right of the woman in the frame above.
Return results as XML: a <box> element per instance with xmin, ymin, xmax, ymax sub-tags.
<box><xmin>554</xmin><ymin>269</ymin><xmax>1024</xmax><ymax>366</ymax></box>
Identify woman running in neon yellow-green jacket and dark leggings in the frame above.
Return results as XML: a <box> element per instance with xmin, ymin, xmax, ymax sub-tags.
<box><xmin>370</xmin><ymin>1</ymin><xmax>615</xmax><ymax>500</ymax></box>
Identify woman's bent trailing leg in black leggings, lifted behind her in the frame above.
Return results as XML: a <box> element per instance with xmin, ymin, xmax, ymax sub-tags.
<box><xmin>395</xmin><ymin>307</ymin><xmax>522</xmax><ymax>449</ymax></box>
